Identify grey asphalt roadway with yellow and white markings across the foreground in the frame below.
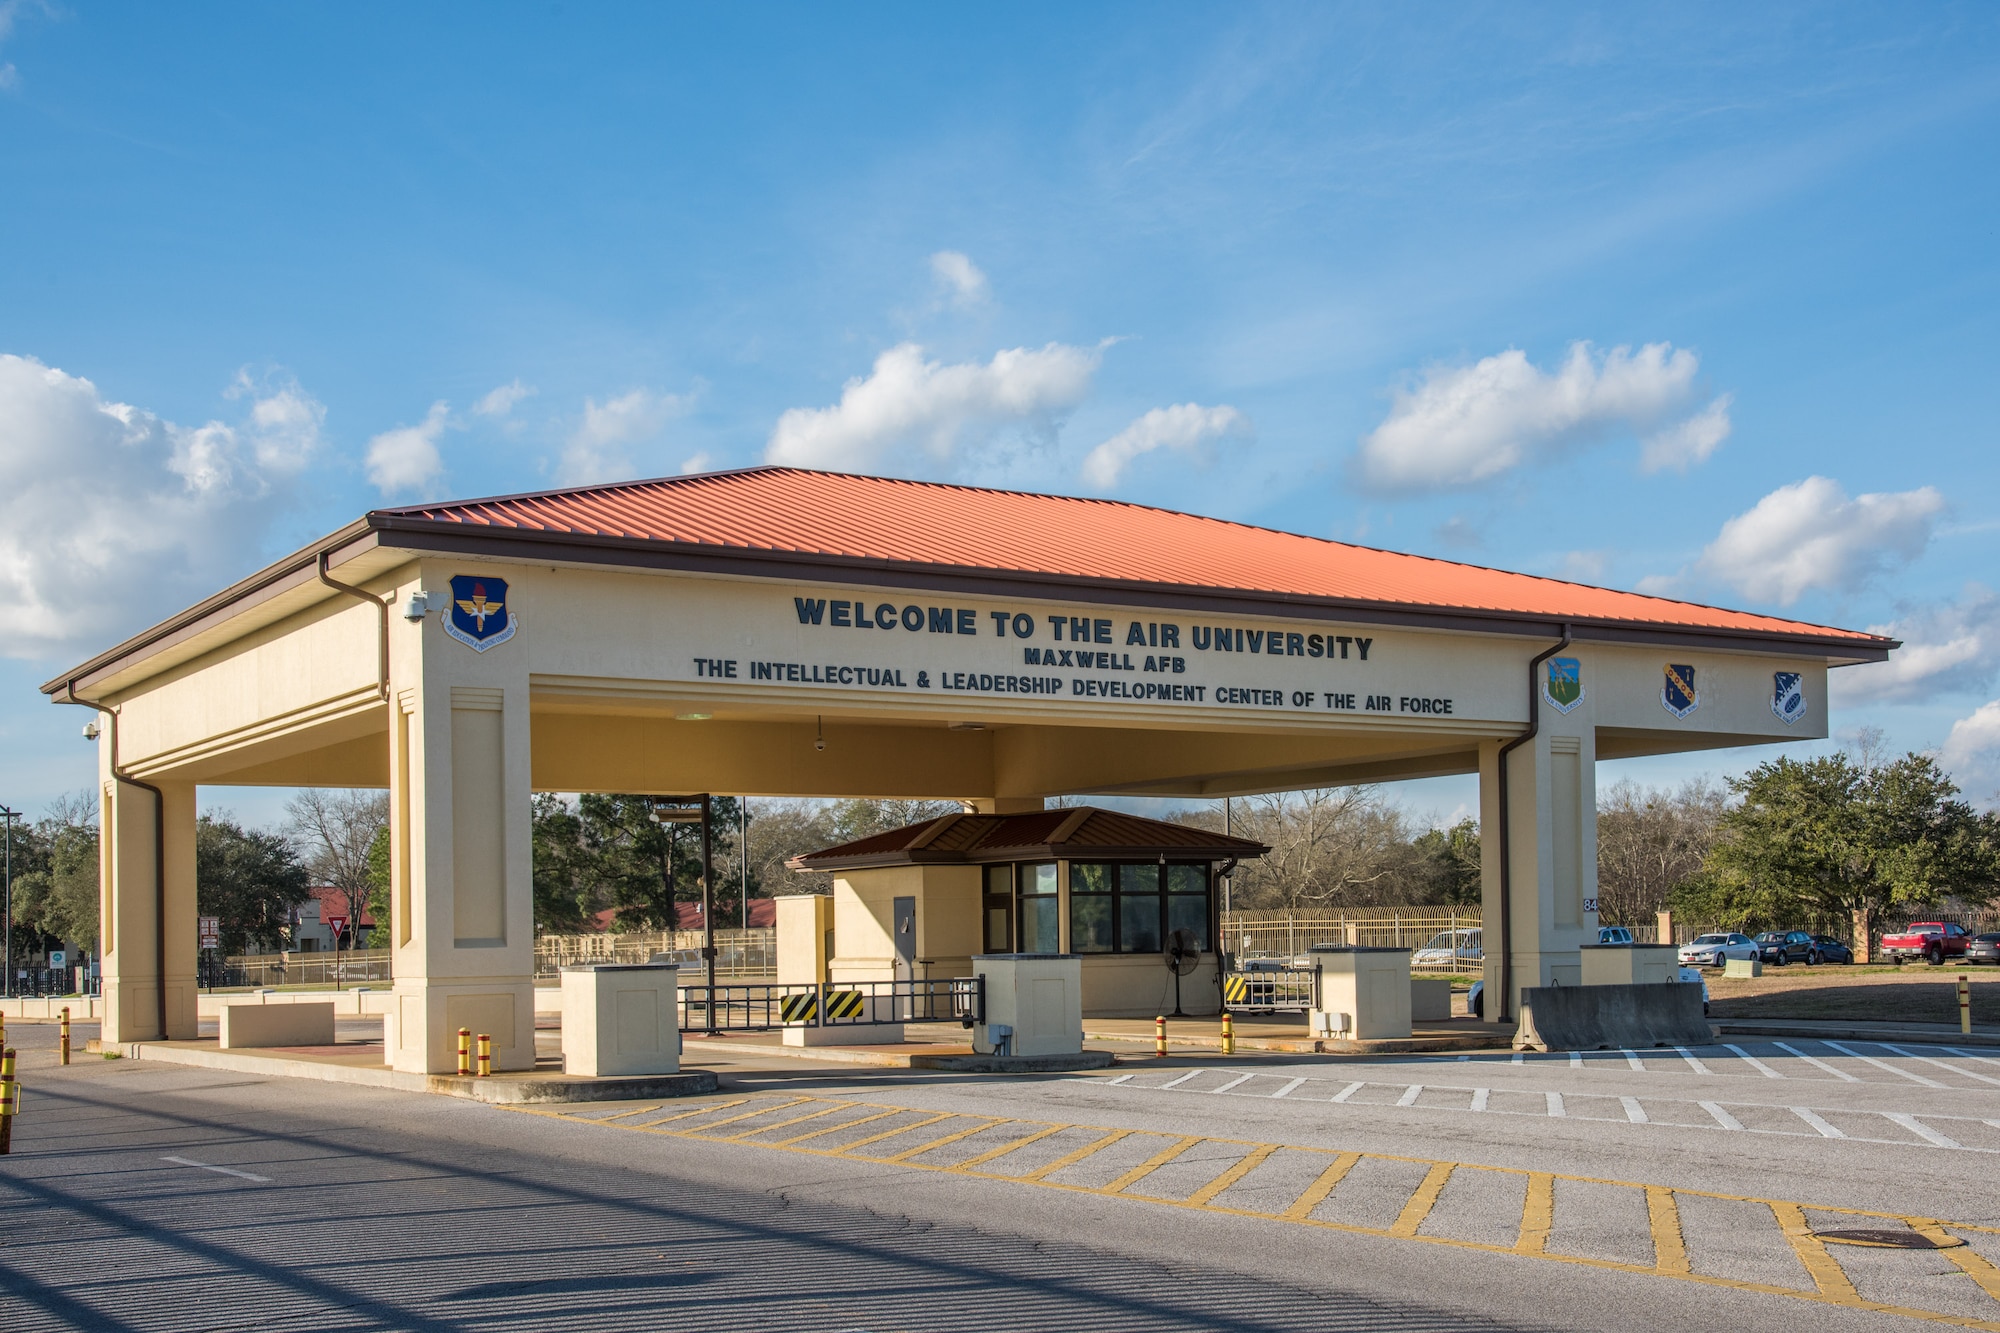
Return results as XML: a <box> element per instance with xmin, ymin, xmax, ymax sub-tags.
<box><xmin>0</xmin><ymin>1025</ymin><xmax>2000</xmax><ymax>1333</ymax></box>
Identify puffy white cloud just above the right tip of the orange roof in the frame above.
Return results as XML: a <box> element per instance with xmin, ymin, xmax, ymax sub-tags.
<box><xmin>1698</xmin><ymin>476</ymin><xmax>1944</xmax><ymax>606</ymax></box>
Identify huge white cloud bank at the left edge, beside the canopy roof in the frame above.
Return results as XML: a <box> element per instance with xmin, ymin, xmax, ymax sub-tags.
<box><xmin>0</xmin><ymin>354</ymin><xmax>324</xmax><ymax>656</ymax></box>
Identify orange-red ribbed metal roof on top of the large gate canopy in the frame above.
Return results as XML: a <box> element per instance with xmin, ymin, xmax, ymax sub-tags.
<box><xmin>376</xmin><ymin>468</ymin><xmax>1894</xmax><ymax>650</ymax></box>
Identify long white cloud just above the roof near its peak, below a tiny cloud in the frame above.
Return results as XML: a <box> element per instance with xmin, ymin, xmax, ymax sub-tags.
<box><xmin>764</xmin><ymin>342</ymin><xmax>1102</xmax><ymax>468</ymax></box>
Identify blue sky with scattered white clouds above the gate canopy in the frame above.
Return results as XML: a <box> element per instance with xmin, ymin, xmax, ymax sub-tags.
<box><xmin>0</xmin><ymin>0</ymin><xmax>2000</xmax><ymax>817</ymax></box>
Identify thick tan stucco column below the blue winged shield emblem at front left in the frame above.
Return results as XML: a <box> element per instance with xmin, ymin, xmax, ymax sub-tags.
<box><xmin>390</xmin><ymin>568</ymin><xmax>534</xmax><ymax>1073</ymax></box>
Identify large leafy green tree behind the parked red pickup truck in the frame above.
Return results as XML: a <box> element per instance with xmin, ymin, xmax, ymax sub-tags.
<box><xmin>1676</xmin><ymin>753</ymin><xmax>2000</xmax><ymax>959</ymax></box>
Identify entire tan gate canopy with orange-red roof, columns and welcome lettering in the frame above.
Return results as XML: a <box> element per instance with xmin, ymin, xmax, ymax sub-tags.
<box><xmin>44</xmin><ymin>468</ymin><xmax>1896</xmax><ymax>1071</ymax></box>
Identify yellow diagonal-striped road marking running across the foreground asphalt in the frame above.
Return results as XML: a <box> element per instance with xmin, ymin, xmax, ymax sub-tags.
<box><xmin>512</xmin><ymin>1095</ymin><xmax>2000</xmax><ymax>1331</ymax></box>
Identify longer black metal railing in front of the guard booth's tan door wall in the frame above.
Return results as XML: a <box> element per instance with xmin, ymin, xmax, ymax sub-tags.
<box><xmin>680</xmin><ymin>977</ymin><xmax>986</xmax><ymax>1033</ymax></box>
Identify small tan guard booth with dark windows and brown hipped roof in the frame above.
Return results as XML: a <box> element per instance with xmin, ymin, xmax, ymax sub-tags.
<box><xmin>778</xmin><ymin>805</ymin><xmax>1270</xmax><ymax>1019</ymax></box>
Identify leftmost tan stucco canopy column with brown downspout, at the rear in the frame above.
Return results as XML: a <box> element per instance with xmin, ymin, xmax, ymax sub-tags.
<box><xmin>98</xmin><ymin>768</ymin><xmax>198</xmax><ymax>1043</ymax></box>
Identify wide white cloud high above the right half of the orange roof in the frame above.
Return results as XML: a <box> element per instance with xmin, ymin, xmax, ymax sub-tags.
<box><xmin>1354</xmin><ymin>342</ymin><xmax>1728</xmax><ymax>490</ymax></box>
